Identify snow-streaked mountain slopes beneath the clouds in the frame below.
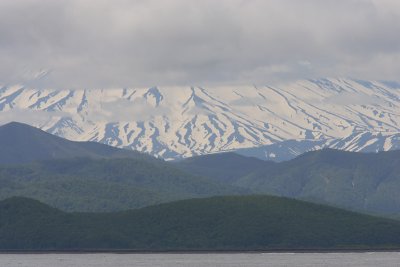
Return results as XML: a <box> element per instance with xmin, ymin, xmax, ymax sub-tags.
<box><xmin>0</xmin><ymin>79</ymin><xmax>400</xmax><ymax>160</ymax></box>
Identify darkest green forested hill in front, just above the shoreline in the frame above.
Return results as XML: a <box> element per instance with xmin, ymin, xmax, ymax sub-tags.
<box><xmin>0</xmin><ymin>196</ymin><xmax>400</xmax><ymax>250</ymax></box>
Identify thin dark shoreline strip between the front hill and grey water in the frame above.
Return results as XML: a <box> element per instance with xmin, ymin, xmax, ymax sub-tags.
<box><xmin>0</xmin><ymin>248</ymin><xmax>400</xmax><ymax>255</ymax></box>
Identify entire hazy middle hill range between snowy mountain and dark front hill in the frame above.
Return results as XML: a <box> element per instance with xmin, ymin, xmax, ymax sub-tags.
<box><xmin>0</xmin><ymin>123</ymin><xmax>400</xmax><ymax>218</ymax></box>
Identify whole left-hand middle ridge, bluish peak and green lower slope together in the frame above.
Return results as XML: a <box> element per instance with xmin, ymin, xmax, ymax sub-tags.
<box><xmin>0</xmin><ymin>123</ymin><xmax>247</xmax><ymax>211</ymax></box>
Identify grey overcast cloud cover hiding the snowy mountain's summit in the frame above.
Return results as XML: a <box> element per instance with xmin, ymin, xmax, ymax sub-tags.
<box><xmin>0</xmin><ymin>0</ymin><xmax>400</xmax><ymax>88</ymax></box>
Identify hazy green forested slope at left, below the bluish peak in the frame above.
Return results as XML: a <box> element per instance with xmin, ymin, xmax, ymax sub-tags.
<box><xmin>0</xmin><ymin>158</ymin><xmax>247</xmax><ymax>214</ymax></box>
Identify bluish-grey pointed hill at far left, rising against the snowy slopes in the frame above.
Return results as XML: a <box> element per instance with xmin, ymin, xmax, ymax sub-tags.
<box><xmin>0</xmin><ymin>122</ymin><xmax>150</xmax><ymax>164</ymax></box>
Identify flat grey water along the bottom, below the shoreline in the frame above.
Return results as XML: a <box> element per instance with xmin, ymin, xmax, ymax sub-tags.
<box><xmin>0</xmin><ymin>252</ymin><xmax>400</xmax><ymax>267</ymax></box>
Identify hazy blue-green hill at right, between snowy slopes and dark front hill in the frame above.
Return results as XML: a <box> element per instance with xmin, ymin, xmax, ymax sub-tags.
<box><xmin>177</xmin><ymin>149</ymin><xmax>400</xmax><ymax>217</ymax></box>
